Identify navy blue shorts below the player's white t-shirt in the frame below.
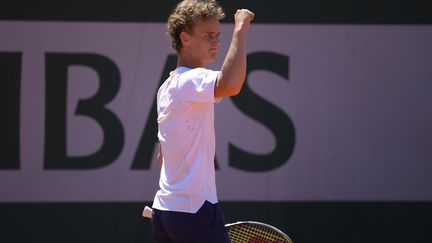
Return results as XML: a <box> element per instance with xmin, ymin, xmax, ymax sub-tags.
<box><xmin>152</xmin><ymin>201</ymin><xmax>230</xmax><ymax>243</ymax></box>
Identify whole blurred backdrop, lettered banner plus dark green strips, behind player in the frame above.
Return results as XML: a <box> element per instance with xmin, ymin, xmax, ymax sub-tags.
<box><xmin>0</xmin><ymin>0</ymin><xmax>432</xmax><ymax>243</ymax></box>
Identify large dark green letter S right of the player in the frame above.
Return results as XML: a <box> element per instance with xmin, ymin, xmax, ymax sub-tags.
<box><xmin>228</xmin><ymin>52</ymin><xmax>295</xmax><ymax>172</ymax></box>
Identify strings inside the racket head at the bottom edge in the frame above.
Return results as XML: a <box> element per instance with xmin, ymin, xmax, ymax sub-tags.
<box><xmin>228</xmin><ymin>224</ymin><xmax>288</xmax><ymax>243</ymax></box>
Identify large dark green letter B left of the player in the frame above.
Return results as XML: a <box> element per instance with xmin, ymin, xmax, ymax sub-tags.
<box><xmin>44</xmin><ymin>53</ymin><xmax>124</xmax><ymax>169</ymax></box>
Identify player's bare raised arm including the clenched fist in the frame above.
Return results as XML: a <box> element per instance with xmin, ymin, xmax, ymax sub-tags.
<box><xmin>215</xmin><ymin>9</ymin><xmax>254</xmax><ymax>97</ymax></box>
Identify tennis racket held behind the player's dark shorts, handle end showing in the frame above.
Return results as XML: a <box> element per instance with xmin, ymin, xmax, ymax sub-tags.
<box><xmin>142</xmin><ymin>206</ymin><xmax>293</xmax><ymax>243</ymax></box>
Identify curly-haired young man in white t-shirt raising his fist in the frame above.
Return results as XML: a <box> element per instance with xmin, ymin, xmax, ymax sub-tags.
<box><xmin>152</xmin><ymin>0</ymin><xmax>254</xmax><ymax>243</ymax></box>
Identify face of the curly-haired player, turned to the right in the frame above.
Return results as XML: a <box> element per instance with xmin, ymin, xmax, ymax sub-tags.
<box><xmin>191</xmin><ymin>18</ymin><xmax>220</xmax><ymax>65</ymax></box>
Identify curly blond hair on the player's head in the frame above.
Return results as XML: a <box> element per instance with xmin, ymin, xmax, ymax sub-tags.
<box><xmin>167</xmin><ymin>0</ymin><xmax>225</xmax><ymax>53</ymax></box>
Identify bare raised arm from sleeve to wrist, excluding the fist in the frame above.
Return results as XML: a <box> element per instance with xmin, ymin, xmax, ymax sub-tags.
<box><xmin>218</xmin><ymin>30</ymin><xmax>246</xmax><ymax>96</ymax></box>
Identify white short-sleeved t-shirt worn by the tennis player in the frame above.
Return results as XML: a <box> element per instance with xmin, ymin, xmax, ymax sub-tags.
<box><xmin>153</xmin><ymin>67</ymin><xmax>219</xmax><ymax>213</ymax></box>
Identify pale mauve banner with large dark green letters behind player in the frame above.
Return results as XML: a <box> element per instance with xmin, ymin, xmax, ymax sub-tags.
<box><xmin>0</xmin><ymin>21</ymin><xmax>432</xmax><ymax>202</ymax></box>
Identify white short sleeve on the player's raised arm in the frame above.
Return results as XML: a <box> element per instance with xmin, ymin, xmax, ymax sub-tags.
<box><xmin>178</xmin><ymin>68</ymin><xmax>220</xmax><ymax>103</ymax></box>
